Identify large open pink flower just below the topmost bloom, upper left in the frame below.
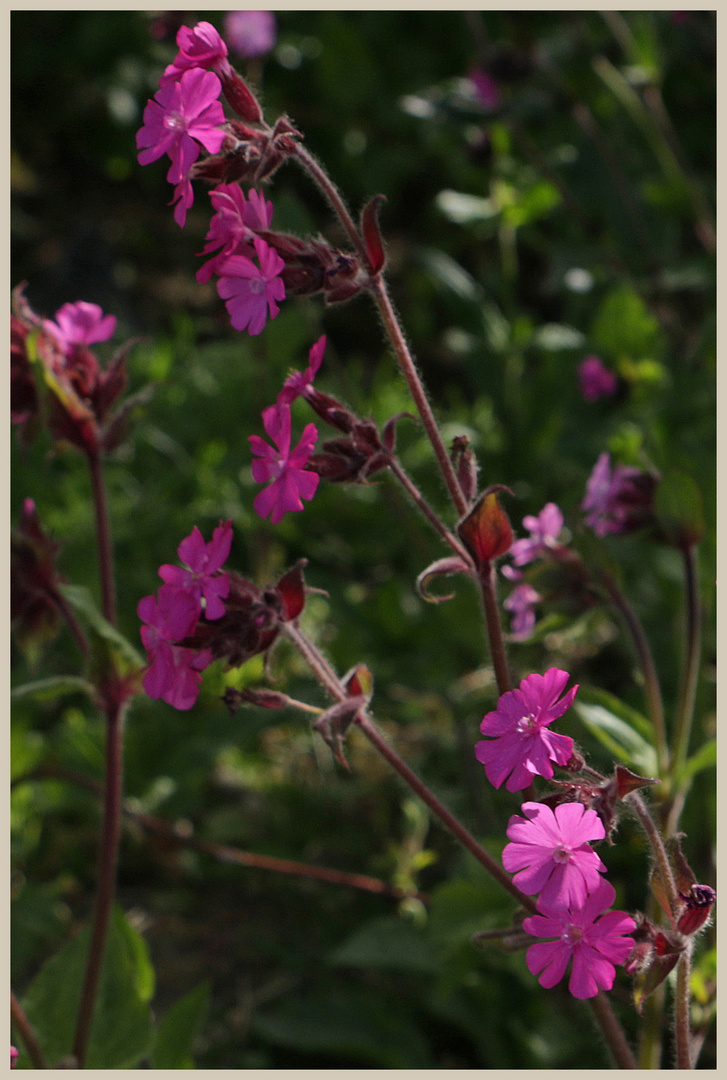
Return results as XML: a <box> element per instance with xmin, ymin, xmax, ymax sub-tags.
<box><xmin>136</xmin><ymin>68</ymin><xmax>225</xmax><ymax>184</ymax></box>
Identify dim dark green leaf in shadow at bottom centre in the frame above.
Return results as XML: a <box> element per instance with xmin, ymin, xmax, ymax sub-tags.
<box><xmin>328</xmin><ymin>916</ymin><xmax>436</xmax><ymax>975</ymax></box>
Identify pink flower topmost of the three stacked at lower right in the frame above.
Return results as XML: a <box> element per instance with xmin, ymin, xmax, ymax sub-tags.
<box><xmin>474</xmin><ymin>667</ymin><xmax>578</xmax><ymax>792</ymax></box>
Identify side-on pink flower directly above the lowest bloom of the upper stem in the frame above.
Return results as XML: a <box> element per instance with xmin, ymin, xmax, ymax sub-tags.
<box><xmin>197</xmin><ymin>184</ymin><xmax>273</xmax><ymax>283</ymax></box>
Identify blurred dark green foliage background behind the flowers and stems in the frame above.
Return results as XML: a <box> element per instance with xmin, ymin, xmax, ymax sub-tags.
<box><xmin>12</xmin><ymin>11</ymin><xmax>715</xmax><ymax>1069</ymax></box>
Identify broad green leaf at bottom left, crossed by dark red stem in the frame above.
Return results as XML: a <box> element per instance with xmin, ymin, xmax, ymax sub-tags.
<box><xmin>23</xmin><ymin>908</ymin><xmax>153</xmax><ymax>1069</ymax></box>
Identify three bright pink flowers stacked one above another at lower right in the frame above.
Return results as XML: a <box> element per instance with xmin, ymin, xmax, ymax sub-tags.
<box><xmin>475</xmin><ymin>667</ymin><xmax>636</xmax><ymax>998</ymax></box>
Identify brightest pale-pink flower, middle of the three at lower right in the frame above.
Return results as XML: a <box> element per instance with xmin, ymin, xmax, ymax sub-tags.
<box><xmin>502</xmin><ymin>802</ymin><xmax>606</xmax><ymax>908</ymax></box>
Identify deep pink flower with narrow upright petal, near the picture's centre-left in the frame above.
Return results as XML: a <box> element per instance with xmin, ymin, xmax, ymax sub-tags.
<box><xmin>248</xmin><ymin>404</ymin><xmax>320</xmax><ymax>525</ymax></box>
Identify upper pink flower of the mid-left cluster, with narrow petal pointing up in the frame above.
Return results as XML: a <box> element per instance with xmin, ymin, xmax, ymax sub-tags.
<box><xmin>159</xmin><ymin>521</ymin><xmax>232</xmax><ymax>619</ymax></box>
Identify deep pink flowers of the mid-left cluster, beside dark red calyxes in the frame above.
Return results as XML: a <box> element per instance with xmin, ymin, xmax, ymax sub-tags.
<box><xmin>136</xmin><ymin>521</ymin><xmax>232</xmax><ymax>710</ymax></box>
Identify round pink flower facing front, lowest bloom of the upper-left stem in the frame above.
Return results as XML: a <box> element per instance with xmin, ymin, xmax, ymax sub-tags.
<box><xmin>217</xmin><ymin>237</ymin><xmax>285</xmax><ymax>335</ymax></box>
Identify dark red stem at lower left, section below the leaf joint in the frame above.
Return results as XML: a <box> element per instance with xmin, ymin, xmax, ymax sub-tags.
<box><xmin>73</xmin><ymin>706</ymin><xmax>124</xmax><ymax>1068</ymax></box>
